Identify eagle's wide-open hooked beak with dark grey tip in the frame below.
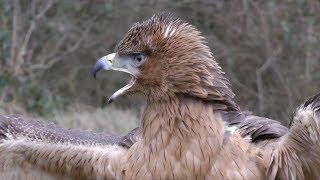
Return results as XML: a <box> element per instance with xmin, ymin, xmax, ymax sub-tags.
<box><xmin>91</xmin><ymin>53</ymin><xmax>136</xmax><ymax>104</ymax></box>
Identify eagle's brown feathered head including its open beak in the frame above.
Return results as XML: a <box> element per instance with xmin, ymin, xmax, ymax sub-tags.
<box><xmin>92</xmin><ymin>14</ymin><xmax>233</xmax><ymax>105</ymax></box>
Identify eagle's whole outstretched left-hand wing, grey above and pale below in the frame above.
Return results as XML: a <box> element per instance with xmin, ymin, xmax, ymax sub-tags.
<box><xmin>0</xmin><ymin>115</ymin><xmax>127</xmax><ymax>179</ymax></box>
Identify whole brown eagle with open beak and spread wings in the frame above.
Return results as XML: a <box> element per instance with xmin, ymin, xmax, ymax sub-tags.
<box><xmin>0</xmin><ymin>14</ymin><xmax>320</xmax><ymax>179</ymax></box>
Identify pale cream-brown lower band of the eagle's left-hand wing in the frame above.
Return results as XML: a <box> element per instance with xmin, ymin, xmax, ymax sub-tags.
<box><xmin>0</xmin><ymin>138</ymin><xmax>126</xmax><ymax>179</ymax></box>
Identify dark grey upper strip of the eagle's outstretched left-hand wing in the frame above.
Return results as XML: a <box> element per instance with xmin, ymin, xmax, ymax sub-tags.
<box><xmin>0</xmin><ymin>115</ymin><xmax>137</xmax><ymax>148</ymax></box>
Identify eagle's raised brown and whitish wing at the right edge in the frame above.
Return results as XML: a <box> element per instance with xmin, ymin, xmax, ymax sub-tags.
<box><xmin>268</xmin><ymin>94</ymin><xmax>320</xmax><ymax>179</ymax></box>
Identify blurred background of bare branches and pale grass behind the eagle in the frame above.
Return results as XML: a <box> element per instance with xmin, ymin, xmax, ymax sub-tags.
<box><xmin>0</xmin><ymin>0</ymin><xmax>320</xmax><ymax>133</ymax></box>
